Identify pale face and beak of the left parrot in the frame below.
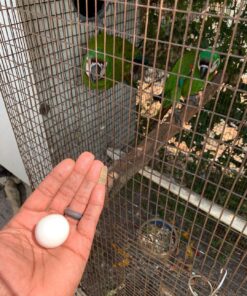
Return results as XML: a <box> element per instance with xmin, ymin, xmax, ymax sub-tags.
<box><xmin>86</xmin><ymin>58</ymin><xmax>107</xmax><ymax>83</ymax></box>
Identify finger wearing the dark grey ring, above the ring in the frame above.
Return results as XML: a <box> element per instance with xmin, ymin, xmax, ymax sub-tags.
<box><xmin>65</xmin><ymin>160</ymin><xmax>104</xmax><ymax>220</ymax></box>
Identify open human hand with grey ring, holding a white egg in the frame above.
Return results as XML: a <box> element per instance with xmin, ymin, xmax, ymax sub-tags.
<box><xmin>0</xmin><ymin>152</ymin><xmax>105</xmax><ymax>296</ymax></box>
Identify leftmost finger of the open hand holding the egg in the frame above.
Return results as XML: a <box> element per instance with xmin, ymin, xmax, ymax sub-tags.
<box><xmin>23</xmin><ymin>159</ymin><xmax>75</xmax><ymax>211</ymax></box>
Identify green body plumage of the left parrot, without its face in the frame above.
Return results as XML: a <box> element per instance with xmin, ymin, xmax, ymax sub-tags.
<box><xmin>82</xmin><ymin>33</ymin><xmax>140</xmax><ymax>89</ymax></box>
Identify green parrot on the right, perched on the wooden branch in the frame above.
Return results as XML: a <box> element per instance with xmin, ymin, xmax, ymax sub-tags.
<box><xmin>157</xmin><ymin>48</ymin><xmax>220</xmax><ymax>118</ymax></box>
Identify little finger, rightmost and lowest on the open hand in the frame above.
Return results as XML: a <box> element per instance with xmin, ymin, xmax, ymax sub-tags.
<box><xmin>77</xmin><ymin>184</ymin><xmax>105</xmax><ymax>252</ymax></box>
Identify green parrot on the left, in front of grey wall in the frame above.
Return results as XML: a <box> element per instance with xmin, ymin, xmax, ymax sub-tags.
<box><xmin>82</xmin><ymin>32</ymin><xmax>142</xmax><ymax>89</ymax></box>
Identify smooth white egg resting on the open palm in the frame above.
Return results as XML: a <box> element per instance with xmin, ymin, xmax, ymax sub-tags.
<box><xmin>35</xmin><ymin>214</ymin><xmax>69</xmax><ymax>248</ymax></box>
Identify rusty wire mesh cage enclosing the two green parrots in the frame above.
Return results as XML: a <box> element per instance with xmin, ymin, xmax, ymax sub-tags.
<box><xmin>0</xmin><ymin>0</ymin><xmax>247</xmax><ymax>296</ymax></box>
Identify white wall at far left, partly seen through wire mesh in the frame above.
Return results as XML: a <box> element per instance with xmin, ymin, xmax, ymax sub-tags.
<box><xmin>0</xmin><ymin>0</ymin><xmax>52</xmax><ymax>187</ymax></box>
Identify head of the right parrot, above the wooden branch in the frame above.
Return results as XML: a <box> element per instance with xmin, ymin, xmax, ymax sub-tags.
<box><xmin>198</xmin><ymin>50</ymin><xmax>220</xmax><ymax>79</ymax></box>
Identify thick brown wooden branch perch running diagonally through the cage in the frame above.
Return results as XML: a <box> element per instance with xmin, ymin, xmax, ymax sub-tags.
<box><xmin>108</xmin><ymin>73</ymin><xmax>227</xmax><ymax>195</ymax></box>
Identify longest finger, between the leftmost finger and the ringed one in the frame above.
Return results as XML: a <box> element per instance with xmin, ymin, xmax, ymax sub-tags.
<box><xmin>49</xmin><ymin>152</ymin><xmax>94</xmax><ymax>214</ymax></box>
